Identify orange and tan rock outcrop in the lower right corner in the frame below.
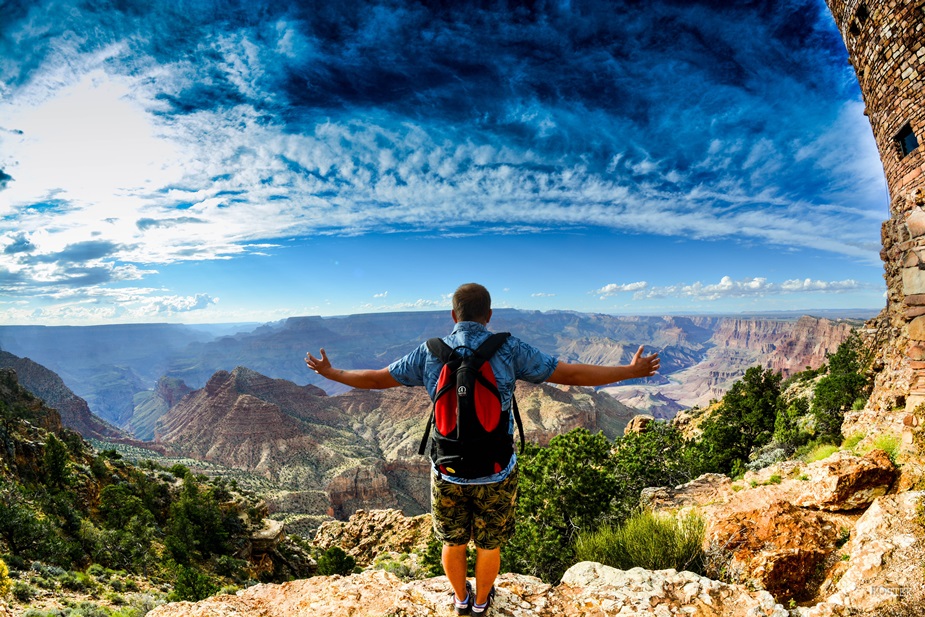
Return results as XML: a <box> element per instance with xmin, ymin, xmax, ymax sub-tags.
<box><xmin>642</xmin><ymin>450</ymin><xmax>925</xmax><ymax>617</ymax></box>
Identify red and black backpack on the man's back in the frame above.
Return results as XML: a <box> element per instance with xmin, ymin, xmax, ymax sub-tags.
<box><xmin>418</xmin><ymin>332</ymin><xmax>524</xmax><ymax>479</ymax></box>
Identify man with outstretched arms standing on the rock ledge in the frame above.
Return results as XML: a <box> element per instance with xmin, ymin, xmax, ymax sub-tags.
<box><xmin>305</xmin><ymin>283</ymin><xmax>659</xmax><ymax>617</ymax></box>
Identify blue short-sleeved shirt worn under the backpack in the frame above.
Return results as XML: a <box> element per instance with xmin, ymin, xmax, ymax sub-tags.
<box><xmin>389</xmin><ymin>321</ymin><xmax>559</xmax><ymax>484</ymax></box>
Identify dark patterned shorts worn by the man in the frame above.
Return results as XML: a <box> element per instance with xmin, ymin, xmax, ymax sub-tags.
<box><xmin>430</xmin><ymin>465</ymin><xmax>518</xmax><ymax>550</ymax></box>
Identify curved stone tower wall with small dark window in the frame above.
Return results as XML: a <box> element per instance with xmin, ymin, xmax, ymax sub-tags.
<box><xmin>826</xmin><ymin>0</ymin><xmax>925</xmax><ymax>418</ymax></box>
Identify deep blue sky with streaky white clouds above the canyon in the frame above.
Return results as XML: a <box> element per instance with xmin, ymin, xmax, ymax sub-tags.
<box><xmin>0</xmin><ymin>0</ymin><xmax>888</xmax><ymax>325</ymax></box>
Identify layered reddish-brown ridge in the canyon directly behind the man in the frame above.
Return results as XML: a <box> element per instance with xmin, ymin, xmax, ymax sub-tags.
<box><xmin>156</xmin><ymin>367</ymin><xmax>634</xmax><ymax>518</ymax></box>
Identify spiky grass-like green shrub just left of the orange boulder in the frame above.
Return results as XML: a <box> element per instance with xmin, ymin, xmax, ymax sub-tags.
<box><xmin>576</xmin><ymin>510</ymin><xmax>706</xmax><ymax>573</ymax></box>
